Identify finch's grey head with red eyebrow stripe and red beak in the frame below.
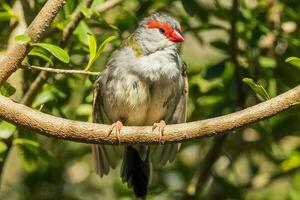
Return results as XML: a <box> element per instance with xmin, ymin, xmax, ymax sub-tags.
<box><xmin>135</xmin><ymin>13</ymin><xmax>184</xmax><ymax>53</ymax></box>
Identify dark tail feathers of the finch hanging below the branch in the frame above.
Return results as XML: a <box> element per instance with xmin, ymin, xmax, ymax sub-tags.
<box><xmin>121</xmin><ymin>146</ymin><xmax>150</xmax><ymax>198</ymax></box>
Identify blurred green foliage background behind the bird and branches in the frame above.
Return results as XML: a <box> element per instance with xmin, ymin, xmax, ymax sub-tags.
<box><xmin>0</xmin><ymin>0</ymin><xmax>300</xmax><ymax>200</ymax></box>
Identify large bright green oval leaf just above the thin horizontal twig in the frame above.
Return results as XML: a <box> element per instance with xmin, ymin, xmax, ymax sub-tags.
<box><xmin>32</xmin><ymin>43</ymin><xmax>70</xmax><ymax>63</ymax></box>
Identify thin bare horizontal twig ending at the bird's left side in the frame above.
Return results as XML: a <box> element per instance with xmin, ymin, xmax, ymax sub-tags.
<box><xmin>22</xmin><ymin>65</ymin><xmax>100</xmax><ymax>76</ymax></box>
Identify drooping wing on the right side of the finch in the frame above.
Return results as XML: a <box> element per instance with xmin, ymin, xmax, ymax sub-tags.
<box><xmin>153</xmin><ymin>62</ymin><xmax>189</xmax><ymax>166</ymax></box>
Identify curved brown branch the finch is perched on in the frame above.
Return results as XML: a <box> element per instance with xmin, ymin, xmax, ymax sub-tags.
<box><xmin>0</xmin><ymin>85</ymin><xmax>300</xmax><ymax>144</ymax></box>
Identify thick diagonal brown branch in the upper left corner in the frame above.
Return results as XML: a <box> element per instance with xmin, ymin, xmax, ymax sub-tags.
<box><xmin>0</xmin><ymin>0</ymin><xmax>65</xmax><ymax>85</ymax></box>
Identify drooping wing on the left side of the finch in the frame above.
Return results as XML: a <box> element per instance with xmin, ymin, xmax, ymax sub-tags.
<box><xmin>92</xmin><ymin>77</ymin><xmax>120</xmax><ymax>177</ymax></box>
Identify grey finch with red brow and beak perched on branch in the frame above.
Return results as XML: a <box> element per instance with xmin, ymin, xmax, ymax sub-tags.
<box><xmin>92</xmin><ymin>13</ymin><xmax>188</xmax><ymax>199</ymax></box>
